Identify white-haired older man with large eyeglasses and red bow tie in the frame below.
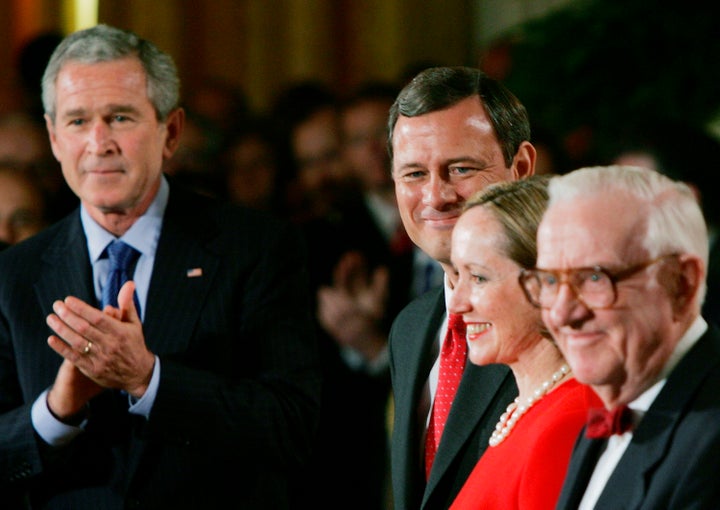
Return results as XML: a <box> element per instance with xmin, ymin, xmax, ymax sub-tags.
<box><xmin>521</xmin><ymin>166</ymin><xmax>720</xmax><ymax>510</ymax></box>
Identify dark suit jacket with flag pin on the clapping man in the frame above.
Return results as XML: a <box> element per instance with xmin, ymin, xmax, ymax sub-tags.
<box><xmin>0</xmin><ymin>181</ymin><xmax>320</xmax><ymax>510</ymax></box>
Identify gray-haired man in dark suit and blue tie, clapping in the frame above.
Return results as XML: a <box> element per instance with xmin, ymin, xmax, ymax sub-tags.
<box><xmin>0</xmin><ymin>25</ymin><xmax>319</xmax><ymax>509</ymax></box>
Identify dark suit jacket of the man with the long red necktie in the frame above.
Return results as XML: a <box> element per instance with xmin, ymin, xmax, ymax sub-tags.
<box><xmin>389</xmin><ymin>286</ymin><xmax>517</xmax><ymax>510</ymax></box>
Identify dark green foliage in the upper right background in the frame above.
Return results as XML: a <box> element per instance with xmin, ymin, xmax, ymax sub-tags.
<box><xmin>505</xmin><ymin>0</ymin><xmax>720</xmax><ymax>151</ymax></box>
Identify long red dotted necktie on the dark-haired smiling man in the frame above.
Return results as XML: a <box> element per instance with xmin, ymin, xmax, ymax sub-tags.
<box><xmin>425</xmin><ymin>314</ymin><xmax>467</xmax><ymax>477</ymax></box>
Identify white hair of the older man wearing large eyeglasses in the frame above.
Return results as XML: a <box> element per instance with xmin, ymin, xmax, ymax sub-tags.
<box><xmin>548</xmin><ymin>165</ymin><xmax>709</xmax><ymax>303</ymax></box>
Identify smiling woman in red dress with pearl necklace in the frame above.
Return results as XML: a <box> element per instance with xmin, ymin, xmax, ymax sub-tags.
<box><xmin>449</xmin><ymin>176</ymin><xmax>600</xmax><ymax>510</ymax></box>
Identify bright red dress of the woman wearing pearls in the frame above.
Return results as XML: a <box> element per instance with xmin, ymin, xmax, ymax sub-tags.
<box><xmin>450</xmin><ymin>379</ymin><xmax>602</xmax><ymax>510</ymax></box>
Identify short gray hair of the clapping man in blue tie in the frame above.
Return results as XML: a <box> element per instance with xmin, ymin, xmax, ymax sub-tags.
<box><xmin>42</xmin><ymin>24</ymin><xmax>180</xmax><ymax>122</ymax></box>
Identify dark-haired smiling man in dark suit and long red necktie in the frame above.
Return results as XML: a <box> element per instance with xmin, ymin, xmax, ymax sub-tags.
<box><xmin>388</xmin><ymin>67</ymin><xmax>536</xmax><ymax>510</ymax></box>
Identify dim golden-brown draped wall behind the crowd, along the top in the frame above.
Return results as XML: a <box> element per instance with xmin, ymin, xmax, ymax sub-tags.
<box><xmin>0</xmin><ymin>0</ymin><xmax>568</xmax><ymax>111</ymax></box>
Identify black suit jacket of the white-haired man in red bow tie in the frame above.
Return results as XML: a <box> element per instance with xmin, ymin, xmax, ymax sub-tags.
<box><xmin>557</xmin><ymin>322</ymin><xmax>720</xmax><ymax>510</ymax></box>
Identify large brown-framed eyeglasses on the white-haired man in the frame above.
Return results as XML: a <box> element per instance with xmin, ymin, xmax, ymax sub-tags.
<box><xmin>518</xmin><ymin>253</ymin><xmax>677</xmax><ymax>309</ymax></box>
